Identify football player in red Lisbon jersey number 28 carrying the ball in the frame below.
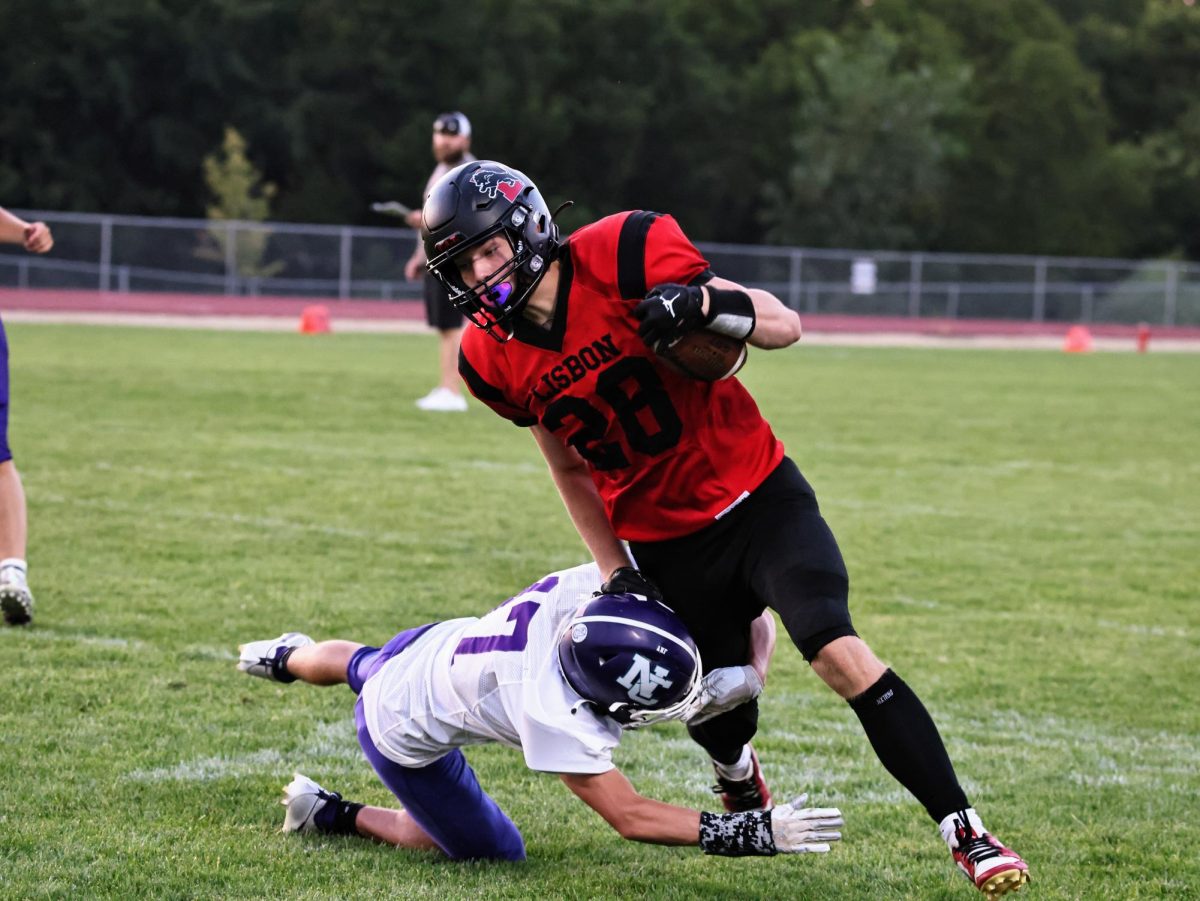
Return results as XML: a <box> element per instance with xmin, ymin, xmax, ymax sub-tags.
<box><xmin>422</xmin><ymin>161</ymin><xmax>1028</xmax><ymax>897</ymax></box>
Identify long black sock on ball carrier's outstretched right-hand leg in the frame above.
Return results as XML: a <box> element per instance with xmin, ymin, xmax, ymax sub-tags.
<box><xmin>848</xmin><ymin>669</ymin><xmax>970</xmax><ymax>823</ymax></box>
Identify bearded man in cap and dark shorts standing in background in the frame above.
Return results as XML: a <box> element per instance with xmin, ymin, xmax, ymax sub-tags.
<box><xmin>404</xmin><ymin>112</ymin><xmax>475</xmax><ymax>413</ymax></box>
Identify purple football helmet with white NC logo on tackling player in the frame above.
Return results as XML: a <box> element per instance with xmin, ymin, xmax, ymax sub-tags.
<box><xmin>558</xmin><ymin>594</ymin><xmax>701</xmax><ymax>728</ymax></box>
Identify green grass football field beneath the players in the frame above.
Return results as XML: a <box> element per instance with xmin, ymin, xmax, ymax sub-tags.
<box><xmin>0</xmin><ymin>324</ymin><xmax>1200</xmax><ymax>899</ymax></box>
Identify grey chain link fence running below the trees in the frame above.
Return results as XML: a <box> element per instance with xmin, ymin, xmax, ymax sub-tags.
<box><xmin>0</xmin><ymin>210</ymin><xmax>1200</xmax><ymax>325</ymax></box>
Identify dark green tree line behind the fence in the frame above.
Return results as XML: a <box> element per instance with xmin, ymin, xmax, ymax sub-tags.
<box><xmin>0</xmin><ymin>0</ymin><xmax>1200</xmax><ymax>259</ymax></box>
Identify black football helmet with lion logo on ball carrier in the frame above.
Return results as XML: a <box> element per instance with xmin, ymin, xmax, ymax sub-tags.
<box><xmin>421</xmin><ymin>160</ymin><xmax>559</xmax><ymax>342</ymax></box>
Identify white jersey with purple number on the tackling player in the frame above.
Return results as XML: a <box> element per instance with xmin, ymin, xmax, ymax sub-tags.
<box><xmin>361</xmin><ymin>564</ymin><xmax>620</xmax><ymax>773</ymax></box>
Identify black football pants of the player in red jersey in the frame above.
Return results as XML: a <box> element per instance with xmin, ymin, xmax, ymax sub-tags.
<box><xmin>630</xmin><ymin>457</ymin><xmax>856</xmax><ymax>669</ymax></box>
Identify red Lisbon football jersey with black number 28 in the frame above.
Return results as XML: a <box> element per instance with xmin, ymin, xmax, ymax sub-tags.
<box><xmin>458</xmin><ymin>211</ymin><xmax>784</xmax><ymax>541</ymax></box>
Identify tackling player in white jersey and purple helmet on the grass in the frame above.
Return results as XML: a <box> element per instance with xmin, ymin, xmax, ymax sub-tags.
<box><xmin>238</xmin><ymin>564</ymin><xmax>842</xmax><ymax>860</ymax></box>
